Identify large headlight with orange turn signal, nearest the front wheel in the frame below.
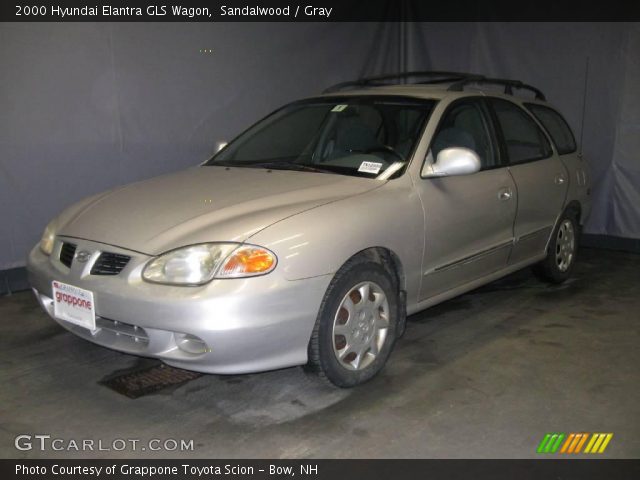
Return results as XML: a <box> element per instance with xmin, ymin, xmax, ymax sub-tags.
<box><xmin>142</xmin><ymin>243</ymin><xmax>276</xmax><ymax>285</ymax></box>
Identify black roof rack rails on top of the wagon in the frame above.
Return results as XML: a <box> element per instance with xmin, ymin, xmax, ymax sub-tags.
<box><xmin>322</xmin><ymin>70</ymin><xmax>545</xmax><ymax>100</ymax></box>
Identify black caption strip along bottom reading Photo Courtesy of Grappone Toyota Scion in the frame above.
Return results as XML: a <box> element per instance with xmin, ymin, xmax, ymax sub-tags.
<box><xmin>0</xmin><ymin>459</ymin><xmax>640</xmax><ymax>480</ymax></box>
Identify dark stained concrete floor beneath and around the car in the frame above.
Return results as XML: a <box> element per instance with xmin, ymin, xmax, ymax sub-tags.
<box><xmin>0</xmin><ymin>250</ymin><xmax>640</xmax><ymax>458</ymax></box>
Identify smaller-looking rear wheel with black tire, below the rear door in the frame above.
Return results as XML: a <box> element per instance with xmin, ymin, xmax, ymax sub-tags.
<box><xmin>533</xmin><ymin>212</ymin><xmax>580</xmax><ymax>284</ymax></box>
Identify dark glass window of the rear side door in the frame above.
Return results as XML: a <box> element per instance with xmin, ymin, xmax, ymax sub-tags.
<box><xmin>491</xmin><ymin>98</ymin><xmax>552</xmax><ymax>164</ymax></box>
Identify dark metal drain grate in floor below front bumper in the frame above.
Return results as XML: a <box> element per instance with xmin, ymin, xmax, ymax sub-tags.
<box><xmin>99</xmin><ymin>364</ymin><xmax>202</xmax><ymax>398</ymax></box>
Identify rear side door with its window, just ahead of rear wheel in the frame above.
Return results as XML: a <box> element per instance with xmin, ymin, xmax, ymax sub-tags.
<box><xmin>489</xmin><ymin>98</ymin><xmax>568</xmax><ymax>264</ymax></box>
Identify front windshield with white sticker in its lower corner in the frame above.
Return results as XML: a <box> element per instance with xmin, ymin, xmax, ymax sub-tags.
<box><xmin>206</xmin><ymin>96</ymin><xmax>433</xmax><ymax>178</ymax></box>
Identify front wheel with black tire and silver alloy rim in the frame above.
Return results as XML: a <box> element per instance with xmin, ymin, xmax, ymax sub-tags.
<box><xmin>306</xmin><ymin>257</ymin><xmax>399</xmax><ymax>388</ymax></box>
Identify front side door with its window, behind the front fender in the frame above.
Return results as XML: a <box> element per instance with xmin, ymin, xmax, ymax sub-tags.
<box><xmin>416</xmin><ymin>97</ymin><xmax>517</xmax><ymax>300</ymax></box>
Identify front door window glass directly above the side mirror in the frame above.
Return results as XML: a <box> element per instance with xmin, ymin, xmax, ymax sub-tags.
<box><xmin>431</xmin><ymin>100</ymin><xmax>499</xmax><ymax>170</ymax></box>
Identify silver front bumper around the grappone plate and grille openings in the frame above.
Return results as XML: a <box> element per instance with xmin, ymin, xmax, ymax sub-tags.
<box><xmin>27</xmin><ymin>238</ymin><xmax>331</xmax><ymax>374</ymax></box>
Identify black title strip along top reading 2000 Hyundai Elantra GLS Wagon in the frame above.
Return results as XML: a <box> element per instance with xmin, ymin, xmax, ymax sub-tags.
<box><xmin>0</xmin><ymin>0</ymin><xmax>640</xmax><ymax>22</ymax></box>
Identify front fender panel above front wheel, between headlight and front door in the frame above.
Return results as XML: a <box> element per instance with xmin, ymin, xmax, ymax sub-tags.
<box><xmin>247</xmin><ymin>175</ymin><xmax>424</xmax><ymax>298</ymax></box>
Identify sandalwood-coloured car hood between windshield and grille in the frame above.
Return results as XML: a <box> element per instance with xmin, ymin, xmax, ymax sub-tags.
<box><xmin>57</xmin><ymin>166</ymin><xmax>383</xmax><ymax>255</ymax></box>
